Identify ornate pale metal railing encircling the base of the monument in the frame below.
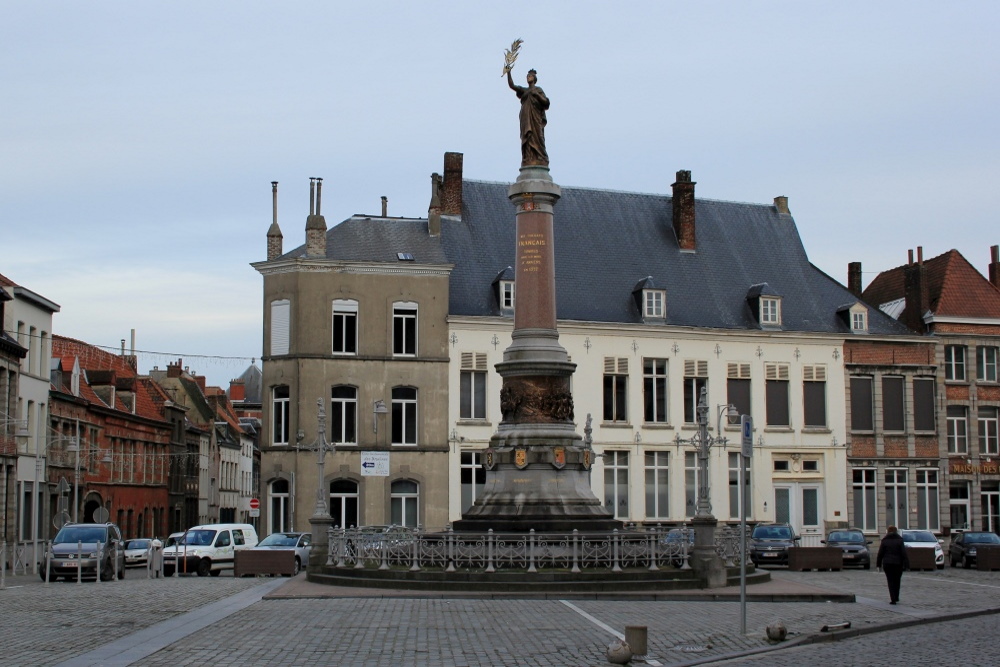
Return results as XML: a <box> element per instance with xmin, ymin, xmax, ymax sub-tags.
<box><xmin>327</xmin><ymin>526</ymin><xmax>752</xmax><ymax>573</ymax></box>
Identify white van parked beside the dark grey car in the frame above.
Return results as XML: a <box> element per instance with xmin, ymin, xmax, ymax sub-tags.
<box><xmin>163</xmin><ymin>523</ymin><xmax>257</xmax><ymax>577</ymax></box>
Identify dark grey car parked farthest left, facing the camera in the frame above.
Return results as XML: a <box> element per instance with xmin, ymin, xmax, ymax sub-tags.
<box><xmin>38</xmin><ymin>523</ymin><xmax>125</xmax><ymax>581</ymax></box>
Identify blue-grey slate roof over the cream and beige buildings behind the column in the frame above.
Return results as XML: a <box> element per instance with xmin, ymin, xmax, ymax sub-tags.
<box><xmin>281</xmin><ymin>180</ymin><xmax>907</xmax><ymax>334</ymax></box>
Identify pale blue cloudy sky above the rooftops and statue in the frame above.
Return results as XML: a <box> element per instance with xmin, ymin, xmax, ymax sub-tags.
<box><xmin>0</xmin><ymin>0</ymin><xmax>1000</xmax><ymax>387</ymax></box>
